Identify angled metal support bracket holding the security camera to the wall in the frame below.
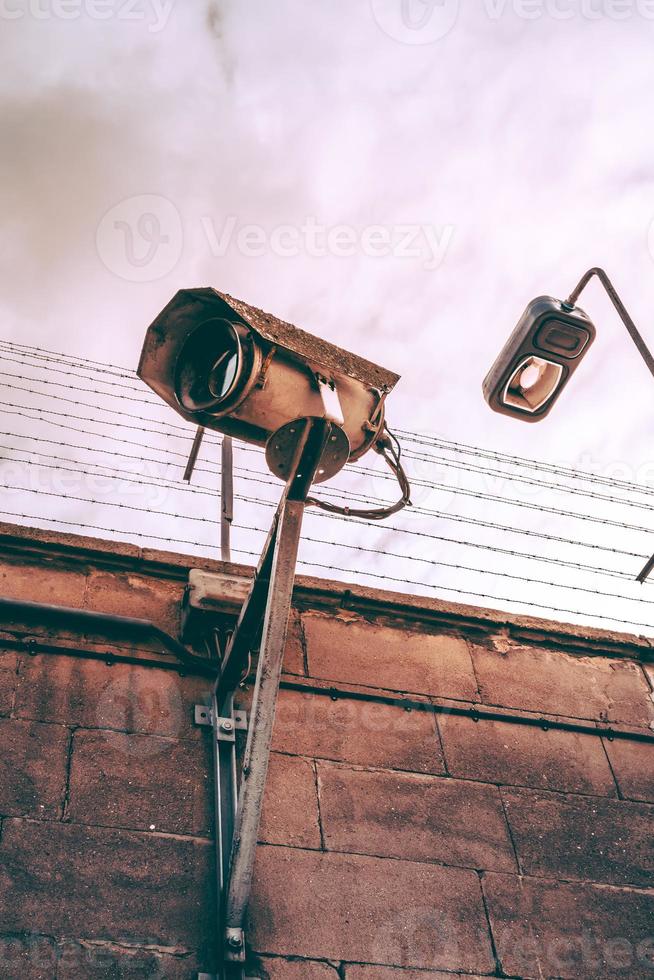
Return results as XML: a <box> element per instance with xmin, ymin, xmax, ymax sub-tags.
<box><xmin>191</xmin><ymin>418</ymin><xmax>337</xmax><ymax>980</ymax></box>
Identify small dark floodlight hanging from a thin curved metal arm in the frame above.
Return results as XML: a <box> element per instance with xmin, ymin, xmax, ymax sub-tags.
<box><xmin>483</xmin><ymin>268</ymin><xmax>654</xmax><ymax>422</ymax></box>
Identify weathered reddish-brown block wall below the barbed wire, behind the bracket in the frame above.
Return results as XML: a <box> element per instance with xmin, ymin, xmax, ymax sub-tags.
<box><xmin>0</xmin><ymin>526</ymin><xmax>654</xmax><ymax>980</ymax></box>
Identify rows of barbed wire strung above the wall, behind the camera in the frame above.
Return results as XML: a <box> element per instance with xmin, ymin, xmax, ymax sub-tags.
<box><xmin>0</xmin><ymin>341</ymin><xmax>654</xmax><ymax>630</ymax></box>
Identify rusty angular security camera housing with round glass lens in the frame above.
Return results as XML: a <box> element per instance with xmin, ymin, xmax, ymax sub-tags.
<box><xmin>138</xmin><ymin>288</ymin><xmax>399</xmax><ymax>482</ymax></box>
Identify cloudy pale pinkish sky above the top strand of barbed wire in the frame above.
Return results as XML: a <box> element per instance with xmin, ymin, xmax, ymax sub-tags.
<box><xmin>0</xmin><ymin>0</ymin><xmax>654</xmax><ymax>636</ymax></box>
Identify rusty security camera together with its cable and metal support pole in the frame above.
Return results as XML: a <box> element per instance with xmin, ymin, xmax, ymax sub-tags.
<box><xmin>138</xmin><ymin>289</ymin><xmax>410</xmax><ymax>980</ymax></box>
